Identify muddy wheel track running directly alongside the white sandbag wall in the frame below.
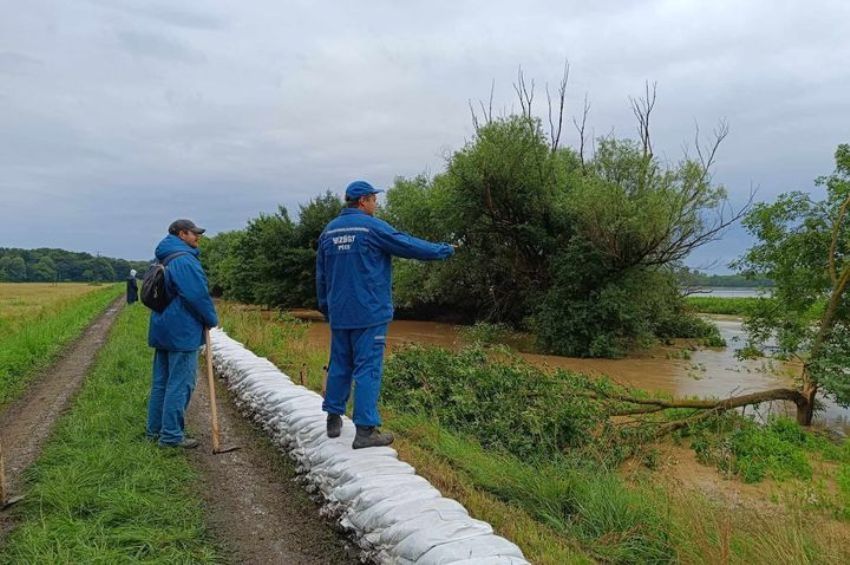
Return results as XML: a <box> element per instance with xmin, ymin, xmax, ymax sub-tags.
<box><xmin>188</xmin><ymin>372</ymin><xmax>359</xmax><ymax>565</ymax></box>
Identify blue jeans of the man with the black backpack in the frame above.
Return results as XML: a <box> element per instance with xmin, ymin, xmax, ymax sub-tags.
<box><xmin>145</xmin><ymin>349</ymin><xmax>198</xmax><ymax>445</ymax></box>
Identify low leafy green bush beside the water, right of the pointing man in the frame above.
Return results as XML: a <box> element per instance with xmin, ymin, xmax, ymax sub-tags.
<box><xmin>383</xmin><ymin>346</ymin><xmax>603</xmax><ymax>458</ymax></box>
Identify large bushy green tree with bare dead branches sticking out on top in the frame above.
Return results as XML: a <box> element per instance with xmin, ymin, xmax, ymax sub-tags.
<box><xmin>386</xmin><ymin>67</ymin><xmax>746</xmax><ymax>356</ymax></box>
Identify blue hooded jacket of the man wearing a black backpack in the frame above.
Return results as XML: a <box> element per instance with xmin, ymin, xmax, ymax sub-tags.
<box><xmin>148</xmin><ymin>235</ymin><xmax>218</xmax><ymax>351</ymax></box>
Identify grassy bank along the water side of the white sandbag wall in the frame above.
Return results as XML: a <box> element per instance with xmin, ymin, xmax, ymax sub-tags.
<box><xmin>219</xmin><ymin>303</ymin><xmax>850</xmax><ymax>564</ymax></box>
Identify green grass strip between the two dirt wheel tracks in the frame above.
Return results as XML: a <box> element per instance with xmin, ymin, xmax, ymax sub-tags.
<box><xmin>0</xmin><ymin>302</ymin><xmax>218</xmax><ymax>564</ymax></box>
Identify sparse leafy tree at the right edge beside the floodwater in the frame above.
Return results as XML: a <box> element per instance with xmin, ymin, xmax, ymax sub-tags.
<box><xmin>739</xmin><ymin>144</ymin><xmax>850</xmax><ymax>425</ymax></box>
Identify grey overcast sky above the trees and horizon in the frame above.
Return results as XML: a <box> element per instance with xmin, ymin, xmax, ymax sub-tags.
<box><xmin>0</xmin><ymin>0</ymin><xmax>850</xmax><ymax>271</ymax></box>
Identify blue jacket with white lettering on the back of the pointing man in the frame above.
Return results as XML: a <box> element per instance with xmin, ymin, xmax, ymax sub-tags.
<box><xmin>316</xmin><ymin>208</ymin><xmax>454</xmax><ymax>330</ymax></box>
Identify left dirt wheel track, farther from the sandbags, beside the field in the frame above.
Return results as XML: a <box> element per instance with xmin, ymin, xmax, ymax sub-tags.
<box><xmin>0</xmin><ymin>296</ymin><xmax>124</xmax><ymax>541</ymax></box>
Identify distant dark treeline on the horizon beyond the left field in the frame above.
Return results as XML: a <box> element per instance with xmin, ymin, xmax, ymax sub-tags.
<box><xmin>0</xmin><ymin>247</ymin><xmax>148</xmax><ymax>282</ymax></box>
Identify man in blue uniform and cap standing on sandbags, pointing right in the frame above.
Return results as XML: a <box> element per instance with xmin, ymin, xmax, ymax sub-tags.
<box><xmin>316</xmin><ymin>181</ymin><xmax>454</xmax><ymax>449</ymax></box>
